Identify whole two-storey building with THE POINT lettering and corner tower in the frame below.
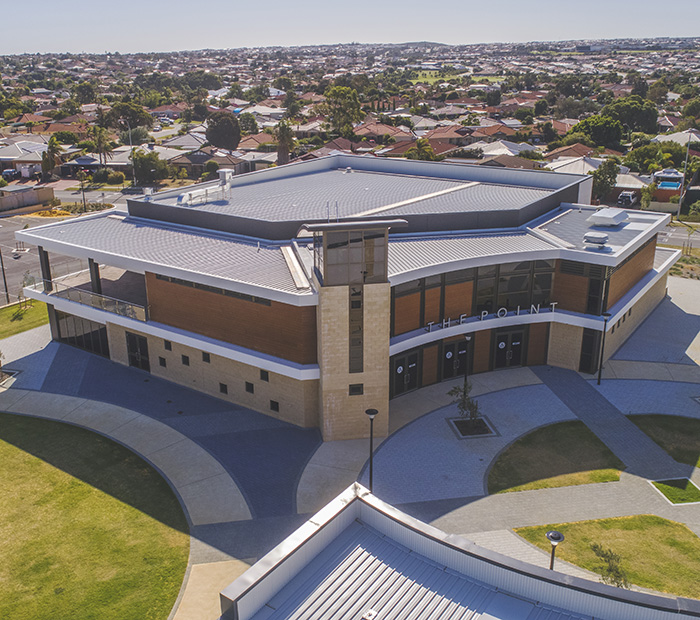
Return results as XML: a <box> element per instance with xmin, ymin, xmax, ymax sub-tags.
<box><xmin>16</xmin><ymin>155</ymin><xmax>679</xmax><ymax>440</ymax></box>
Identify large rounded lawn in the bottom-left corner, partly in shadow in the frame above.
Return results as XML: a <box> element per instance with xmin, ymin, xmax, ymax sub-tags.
<box><xmin>0</xmin><ymin>413</ymin><xmax>189</xmax><ymax>620</ymax></box>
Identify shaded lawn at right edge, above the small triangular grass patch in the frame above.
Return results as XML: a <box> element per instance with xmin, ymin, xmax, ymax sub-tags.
<box><xmin>628</xmin><ymin>414</ymin><xmax>700</xmax><ymax>467</ymax></box>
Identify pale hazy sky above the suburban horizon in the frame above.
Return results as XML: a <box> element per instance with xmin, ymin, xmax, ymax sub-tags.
<box><xmin>0</xmin><ymin>0</ymin><xmax>700</xmax><ymax>55</ymax></box>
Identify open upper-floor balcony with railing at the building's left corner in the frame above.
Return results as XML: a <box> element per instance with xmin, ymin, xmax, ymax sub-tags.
<box><xmin>24</xmin><ymin>267</ymin><xmax>148</xmax><ymax>321</ymax></box>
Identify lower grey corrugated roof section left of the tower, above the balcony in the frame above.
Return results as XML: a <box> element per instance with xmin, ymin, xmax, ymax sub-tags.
<box><xmin>23</xmin><ymin>214</ymin><xmax>299</xmax><ymax>293</ymax></box>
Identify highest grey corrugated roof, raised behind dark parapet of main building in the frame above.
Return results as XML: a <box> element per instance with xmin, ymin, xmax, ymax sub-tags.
<box><xmin>153</xmin><ymin>169</ymin><xmax>551</xmax><ymax>221</ymax></box>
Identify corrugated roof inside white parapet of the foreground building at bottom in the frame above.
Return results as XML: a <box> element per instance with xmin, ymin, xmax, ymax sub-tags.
<box><xmin>253</xmin><ymin>521</ymin><xmax>578</xmax><ymax>620</ymax></box>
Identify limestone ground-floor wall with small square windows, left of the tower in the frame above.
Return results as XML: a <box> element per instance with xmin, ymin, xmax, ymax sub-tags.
<box><xmin>107</xmin><ymin>323</ymin><xmax>319</xmax><ymax>427</ymax></box>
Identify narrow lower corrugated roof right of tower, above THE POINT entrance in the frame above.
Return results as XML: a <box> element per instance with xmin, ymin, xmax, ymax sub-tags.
<box><xmin>389</xmin><ymin>231</ymin><xmax>555</xmax><ymax>277</ymax></box>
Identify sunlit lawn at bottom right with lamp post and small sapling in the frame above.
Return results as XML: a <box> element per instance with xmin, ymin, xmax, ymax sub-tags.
<box><xmin>515</xmin><ymin>515</ymin><xmax>700</xmax><ymax>598</ymax></box>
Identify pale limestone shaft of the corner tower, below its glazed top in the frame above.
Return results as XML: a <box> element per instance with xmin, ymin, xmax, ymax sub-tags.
<box><xmin>317</xmin><ymin>283</ymin><xmax>391</xmax><ymax>441</ymax></box>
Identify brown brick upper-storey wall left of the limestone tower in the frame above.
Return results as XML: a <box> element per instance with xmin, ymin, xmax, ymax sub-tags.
<box><xmin>146</xmin><ymin>273</ymin><xmax>316</xmax><ymax>364</ymax></box>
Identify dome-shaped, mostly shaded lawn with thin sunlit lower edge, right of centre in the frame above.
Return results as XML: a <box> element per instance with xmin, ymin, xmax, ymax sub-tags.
<box><xmin>488</xmin><ymin>421</ymin><xmax>625</xmax><ymax>493</ymax></box>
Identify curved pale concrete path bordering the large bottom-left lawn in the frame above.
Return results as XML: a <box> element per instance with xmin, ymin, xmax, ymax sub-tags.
<box><xmin>0</xmin><ymin>388</ymin><xmax>251</xmax><ymax>620</ymax></box>
